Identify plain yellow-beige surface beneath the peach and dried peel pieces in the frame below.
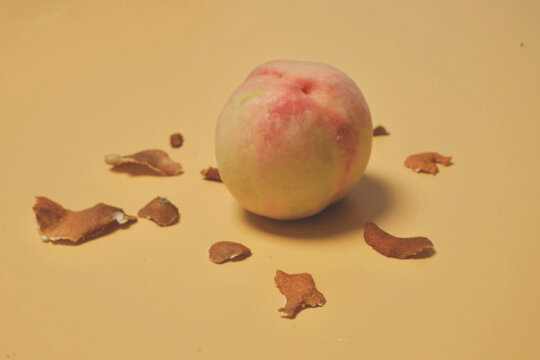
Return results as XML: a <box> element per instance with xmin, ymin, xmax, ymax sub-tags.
<box><xmin>0</xmin><ymin>0</ymin><xmax>540</xmax><ymax>360</ymax></box>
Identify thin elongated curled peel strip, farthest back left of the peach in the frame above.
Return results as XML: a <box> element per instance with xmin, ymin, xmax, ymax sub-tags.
<box><xmin>105</xmin><ymin>150</ymin><xmax>183</xmax><ymax>176</ymax></box>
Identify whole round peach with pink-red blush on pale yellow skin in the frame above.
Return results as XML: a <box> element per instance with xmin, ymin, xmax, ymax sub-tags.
<box><xmin>216</xmin><ymin>60</ymin><xmax>372</xmax><ymax>219</ymax></box>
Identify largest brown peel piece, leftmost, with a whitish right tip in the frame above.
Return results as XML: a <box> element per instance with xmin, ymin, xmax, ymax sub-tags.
<box><xmin>32</xmin><ymin>196</ymin><xmax>137</xmax><ymax>243</ymax></box>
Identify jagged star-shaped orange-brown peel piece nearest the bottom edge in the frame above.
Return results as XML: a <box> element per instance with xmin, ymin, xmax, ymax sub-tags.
<box><xmin>274</xmin><ymin>270</ymin><xmax>326</xmax><ymax>319</ymax></box>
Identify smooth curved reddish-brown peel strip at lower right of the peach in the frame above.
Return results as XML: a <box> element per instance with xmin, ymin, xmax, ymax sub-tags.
<box><xmin>364</xmin><ymin>222</ymin><xmax>433</xmax><ymax>259</ymax></box>
